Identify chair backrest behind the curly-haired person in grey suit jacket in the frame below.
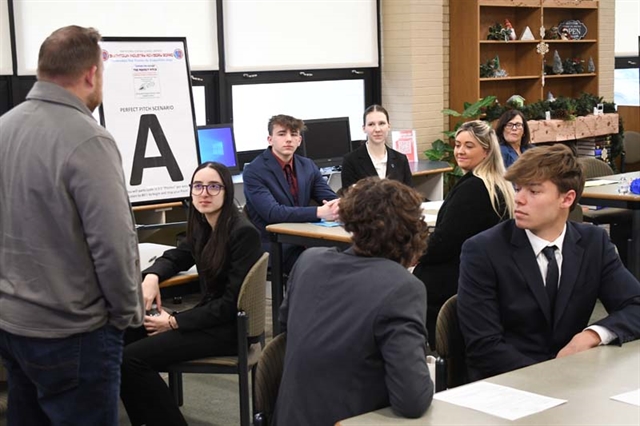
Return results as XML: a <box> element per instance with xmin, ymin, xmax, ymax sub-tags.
<box><xmin>254</xmin><ymin>333</ymin><xmax>287</xmax><ymax>426</ymax></box>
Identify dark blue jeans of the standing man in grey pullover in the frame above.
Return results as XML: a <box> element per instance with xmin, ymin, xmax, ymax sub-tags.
<box><xmin>0</xmin><ymin>325</ymin><xmax>123</xmax><ymax>426</ymax></box>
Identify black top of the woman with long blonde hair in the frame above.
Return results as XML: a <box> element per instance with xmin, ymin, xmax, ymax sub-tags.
<box><xmin>413</xmin><ymin>172</ymin><xmax>507</xmax><ymax>347</ymax></box>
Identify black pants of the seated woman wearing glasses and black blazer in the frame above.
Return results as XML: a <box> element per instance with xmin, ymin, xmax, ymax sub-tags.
<box><xmin>120</xmin><ymin>324</ymin><xmax>238</xmax><ymax>426</ymax></box>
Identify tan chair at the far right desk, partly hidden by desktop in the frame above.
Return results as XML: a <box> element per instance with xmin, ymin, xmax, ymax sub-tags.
<box><xmin>578</xmin><ymin>157</ymin><xmax>632</xmax><ymax>265</ymax></box>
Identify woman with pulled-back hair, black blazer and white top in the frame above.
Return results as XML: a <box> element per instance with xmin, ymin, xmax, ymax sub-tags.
<box><xmin>341</xmin><ymin>105</ymin><xmax>412</xmax><ymax>190</ymax></box>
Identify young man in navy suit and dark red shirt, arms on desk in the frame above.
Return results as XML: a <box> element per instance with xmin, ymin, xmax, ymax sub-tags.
<box><xmin>242</xmin><ymin>115</ymin><xmax>338</xmax><ymax>271</ymax></box>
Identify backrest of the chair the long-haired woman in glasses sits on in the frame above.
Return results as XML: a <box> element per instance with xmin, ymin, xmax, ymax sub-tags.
<box><xmin>238</xmin><ymin>253</ymin><xmax>269</xmax><ymax>337</ymax></box>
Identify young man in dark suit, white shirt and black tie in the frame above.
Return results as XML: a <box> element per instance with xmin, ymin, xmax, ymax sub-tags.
<box><xmin>458</xmin><ymin>144</ymin><xmax>640</xmax><ymax>380</ymax></box>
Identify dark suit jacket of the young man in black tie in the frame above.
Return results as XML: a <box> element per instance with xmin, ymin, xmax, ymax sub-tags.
<box><xmin>458</xmin><ymin>220</ymin><xmax>640</xmax><ymax>380</ymax></box>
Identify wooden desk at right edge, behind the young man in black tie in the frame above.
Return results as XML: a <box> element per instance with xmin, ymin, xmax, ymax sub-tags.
<box><xmin>580</xmin><ymin>172</ymin><xmax>640</xmax><ymax>280</ymax></box>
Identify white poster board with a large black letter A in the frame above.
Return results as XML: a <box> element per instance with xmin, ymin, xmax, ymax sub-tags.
<box><xmin>100</xmin><ymin>37</ymin><xmax>198</xmax><ymax>205</ymax></box>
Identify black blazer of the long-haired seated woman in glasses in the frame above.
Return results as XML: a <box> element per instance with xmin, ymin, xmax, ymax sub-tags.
<box><xmin>143</xmin><ymin>216</ymin><xmax>263</xmax><ymax>331</ymax></box>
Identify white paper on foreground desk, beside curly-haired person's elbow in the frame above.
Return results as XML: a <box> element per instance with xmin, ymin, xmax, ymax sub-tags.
<box><xmin>433</xmin><ymin>382</ymin><xmax>567</xmax><ymax>420</ymax></box>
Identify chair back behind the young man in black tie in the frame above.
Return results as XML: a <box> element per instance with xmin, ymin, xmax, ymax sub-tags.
<box><xmin>436</xmin><ymin>295</ymin><xmax>469</xmax><ymax>392</ymax></box>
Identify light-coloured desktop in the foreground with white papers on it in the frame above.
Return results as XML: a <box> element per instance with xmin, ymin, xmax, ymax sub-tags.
<box><xmin>336</xmin><ymin>340</ymin><xmax>640</xmax><ymax>426</ymax></box>
